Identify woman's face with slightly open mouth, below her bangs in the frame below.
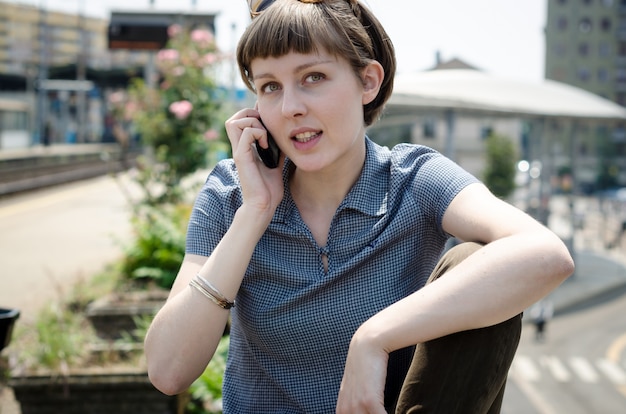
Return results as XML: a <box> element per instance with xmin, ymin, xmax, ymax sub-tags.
<box><xmin>251</xmin><ymin>49</ymin><xmax>373</xmax><ymax>172</ymax></box>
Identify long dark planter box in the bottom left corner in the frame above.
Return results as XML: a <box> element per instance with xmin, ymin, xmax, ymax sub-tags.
<box><xmin>9</xmin><ymin>369</ymin><xmax>187</xmax><ymax>414</ymax></box>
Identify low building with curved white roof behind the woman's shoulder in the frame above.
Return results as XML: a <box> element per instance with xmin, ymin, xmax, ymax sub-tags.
<box><xmin>368</xmin><ymin>60</ymin><xmax>626</xmax><ymax>200</ymax></box>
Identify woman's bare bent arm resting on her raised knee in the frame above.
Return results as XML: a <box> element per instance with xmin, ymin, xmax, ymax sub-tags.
<box><xmin>338</xmin><ymin>184</ymin><xmax>574</xmax><ymax>411</ymax></box>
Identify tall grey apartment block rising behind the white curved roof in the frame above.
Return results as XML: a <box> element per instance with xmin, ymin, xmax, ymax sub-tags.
<box><xmin>545</xmin><ymin>0</ymin><xmax>626</xmax><ymax>191</ymax></box>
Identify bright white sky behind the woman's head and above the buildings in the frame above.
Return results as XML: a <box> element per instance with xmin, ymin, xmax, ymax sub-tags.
<box><xmin>5</xmin><ymin>0</ymin><xmax>547</xmax><ymax>81</ymax></box>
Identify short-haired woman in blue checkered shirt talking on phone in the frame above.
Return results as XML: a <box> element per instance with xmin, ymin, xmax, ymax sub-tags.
<box><xmin>145</xmin><ymin>0</ymin><xmax>573</xmax><ymax>414</ymax></box>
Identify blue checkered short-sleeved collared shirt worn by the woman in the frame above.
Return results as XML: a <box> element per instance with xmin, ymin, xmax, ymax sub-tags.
<box><xmin>186</xmin><ymin>138</ymin><xmax>477</xmax><ymax>414</ymax></box>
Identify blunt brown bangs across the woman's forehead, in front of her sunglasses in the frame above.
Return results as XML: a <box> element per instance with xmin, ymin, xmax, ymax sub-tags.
<box><xmin>237</xmin><ymin>0</ymin><xmax>364</xmax><ymax>91</ymax></box>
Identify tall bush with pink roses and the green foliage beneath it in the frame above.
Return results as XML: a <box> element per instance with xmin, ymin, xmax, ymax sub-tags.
<box><xmin>108</xmin><ymin>25</ymin><xmax>230</xmax><ymax>288</ymax></box>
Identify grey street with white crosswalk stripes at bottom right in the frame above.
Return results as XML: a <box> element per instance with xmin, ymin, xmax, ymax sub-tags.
<box><xmin>502</xmin><ymin>276</ymin><xmax>626</xmax><ymax>414</ymax></box>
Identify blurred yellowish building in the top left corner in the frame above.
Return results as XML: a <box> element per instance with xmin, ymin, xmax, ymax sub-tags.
<box><xmin>0</xmin><ymin>1</ymin><xmax>156</xmax><ymax>91</ymax></box>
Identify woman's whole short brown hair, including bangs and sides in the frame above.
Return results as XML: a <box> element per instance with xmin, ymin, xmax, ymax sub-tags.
<box><xmin>237</xmin><ymin>0</ymin><xmax>396</xmax><ymax>126</ymax></box>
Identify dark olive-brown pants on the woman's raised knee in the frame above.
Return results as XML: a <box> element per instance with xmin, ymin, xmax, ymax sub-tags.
<box><xmin>387</xmin><ymin>243</ymin><xmax>522</xmax><ymax>414</ymax></box>
